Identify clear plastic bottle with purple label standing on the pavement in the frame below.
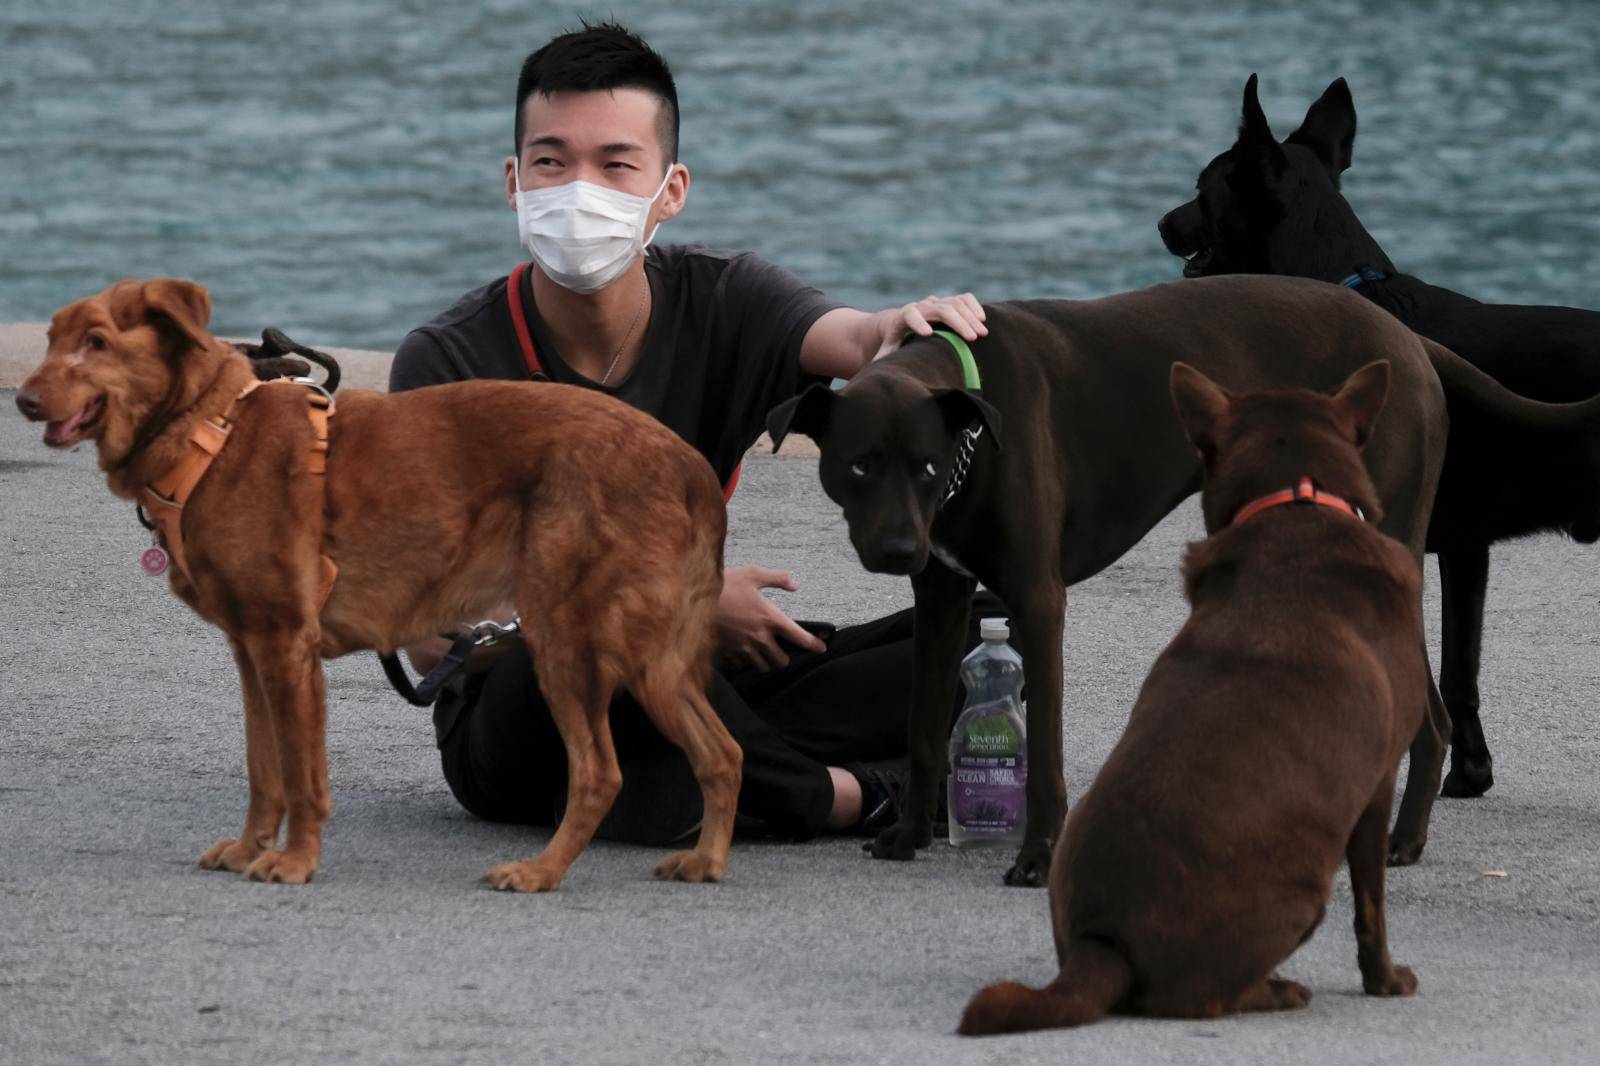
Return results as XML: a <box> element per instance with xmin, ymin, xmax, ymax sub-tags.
<box><xmin>949</xmin><ymin>618</ymin><xmax>1027</xmax><ymax>847</ymax></box>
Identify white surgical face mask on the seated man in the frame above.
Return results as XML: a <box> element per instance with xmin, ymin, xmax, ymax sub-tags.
<box><xmin>510</xmin><ymin>160</ymin><xmax>672</xmax><ymax>293</ymax></box>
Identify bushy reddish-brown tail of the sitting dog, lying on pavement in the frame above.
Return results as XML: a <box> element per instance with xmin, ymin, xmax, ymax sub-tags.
<box><xmin>957</xmin><ymin>940</ymin><xmax>1133</xmax><ymax>1036</ymax></box>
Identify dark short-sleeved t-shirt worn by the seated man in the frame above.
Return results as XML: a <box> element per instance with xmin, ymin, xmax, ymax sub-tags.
<box><xmin>389</xmin><ymin>245</ymin><xmax>842</xmax><ymax>482</ymax></box>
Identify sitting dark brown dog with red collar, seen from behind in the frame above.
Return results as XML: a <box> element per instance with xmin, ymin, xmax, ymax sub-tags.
<box><xmin>960</xmin><ymin>363</ymin><xmax>1427</xmax><ymax>1036</ymax></box>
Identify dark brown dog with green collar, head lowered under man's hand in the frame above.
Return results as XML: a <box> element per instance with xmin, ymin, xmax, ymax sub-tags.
<box><xmin>768</xmin><ymin>277</ymin><xmax>1592</xmax><ymax>885</ymax></box>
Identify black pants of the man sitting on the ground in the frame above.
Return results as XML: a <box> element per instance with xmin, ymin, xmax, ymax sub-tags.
<box><xmin>434</xmin><ymin>592</ymin><xmax>1005</xmax><ymax>845</ymax></box>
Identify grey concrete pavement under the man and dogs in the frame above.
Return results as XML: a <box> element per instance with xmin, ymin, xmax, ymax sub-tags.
<box><xmin>0</xmin><ymin>394</ymin><xmax>1600</xmax><ymax>1066</ymax></box>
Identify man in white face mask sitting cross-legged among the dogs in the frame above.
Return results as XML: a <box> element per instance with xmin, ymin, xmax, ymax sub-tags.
<box><xmin>390</xmin><ymin>24</ymin><xmax>987</xmax><ymax>844</ymax></box>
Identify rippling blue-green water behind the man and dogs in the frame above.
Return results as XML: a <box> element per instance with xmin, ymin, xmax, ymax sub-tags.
<box><xmin>0</xmin><ymin>0</ymin><xmax>1600</xmax><ymax>347</ymax></box>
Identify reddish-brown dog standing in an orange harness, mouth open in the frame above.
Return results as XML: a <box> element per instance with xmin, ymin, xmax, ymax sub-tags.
<box><xmin>16</xmin><ymin>280</ymin><xmax>741</xmax><ymax>892</ymax></box>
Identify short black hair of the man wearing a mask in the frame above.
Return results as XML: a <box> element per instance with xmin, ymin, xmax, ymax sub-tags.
<box><xmin>512</xmin><ymin>22</ymin><xmax>678</xmax><ymax>163</ymax></box>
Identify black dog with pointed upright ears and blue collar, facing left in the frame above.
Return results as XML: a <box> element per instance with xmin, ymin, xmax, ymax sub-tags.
<box><xmin>1160</xmin><ymin>75</ymin><xmax>1600</xmax><ymax>816</ymax></box>
